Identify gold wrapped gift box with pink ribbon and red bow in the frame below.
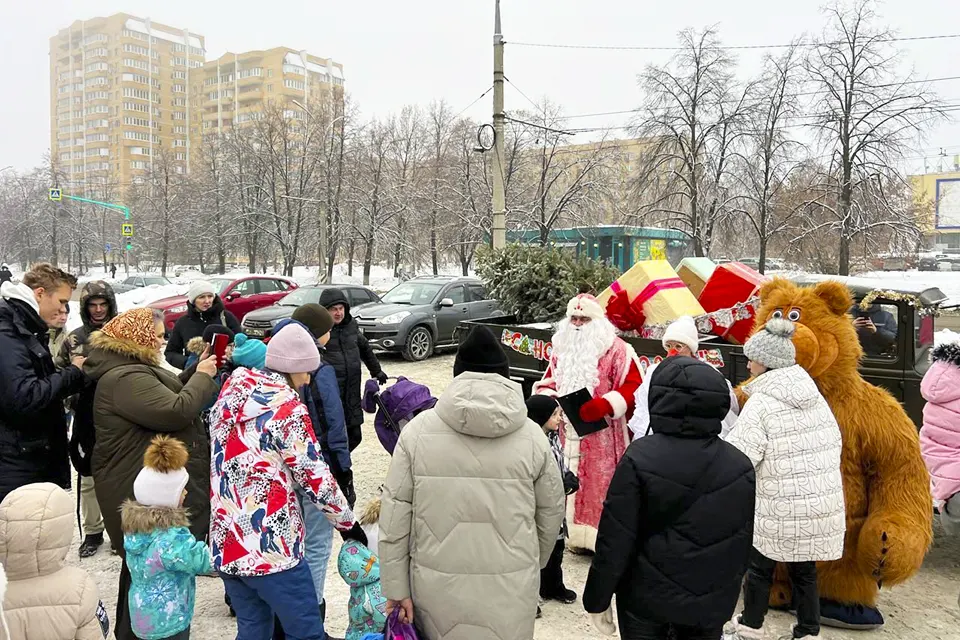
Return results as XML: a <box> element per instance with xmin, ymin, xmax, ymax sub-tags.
<box><xmin>599</xmin><ymin>260</ymin><xmax>703</xmax><ymax>324</ymax></box>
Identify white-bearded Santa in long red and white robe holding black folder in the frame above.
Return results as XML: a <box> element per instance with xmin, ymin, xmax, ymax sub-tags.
<box><xmin>533</xmin><ymin>294</ymin><xmax>642</xmax><ymax>550</ymax></box>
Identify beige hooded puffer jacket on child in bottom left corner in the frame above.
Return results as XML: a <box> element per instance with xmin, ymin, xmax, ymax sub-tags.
<box><xmin>0</xmin><ymin>482</ymin><xmax>106</xmax><ymax>640</ymax></box>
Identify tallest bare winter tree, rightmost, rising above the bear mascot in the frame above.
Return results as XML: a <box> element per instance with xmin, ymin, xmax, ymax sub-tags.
<box><xmin>798</xmin><ymin>0</ymin><xmax>943</xmax><ymax>275</ymax></box>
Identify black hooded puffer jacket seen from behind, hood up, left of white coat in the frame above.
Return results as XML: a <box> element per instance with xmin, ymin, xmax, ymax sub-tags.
<box><xmin>583</xmin><ymin>357</ymin><xmax>756</xmax><ymax>627</ymax></box>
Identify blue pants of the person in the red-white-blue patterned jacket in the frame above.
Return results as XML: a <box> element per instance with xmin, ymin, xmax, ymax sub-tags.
<box><xmin>220</xmin><ymin>562</ymin><xmax>327</xmax><ymax>640</ymax></box>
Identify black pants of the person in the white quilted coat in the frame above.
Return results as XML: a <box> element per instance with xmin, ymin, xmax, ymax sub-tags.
<box><xmin>740</xmin><ymin>549</ymin><xmax>820</xmax><ymax>638</ymax></box>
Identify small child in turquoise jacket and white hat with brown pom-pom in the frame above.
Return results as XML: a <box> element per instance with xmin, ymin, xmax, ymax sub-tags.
<box><xmin>120</xmin><ymin>435</ymin><xmax>213</xmax><ymax>640</ymax></box>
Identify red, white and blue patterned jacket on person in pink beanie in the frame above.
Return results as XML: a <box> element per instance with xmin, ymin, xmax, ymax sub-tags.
<box><xmin>210</xmin><ymin>367</ymin><xmax>354</xmax><ymax>576</ymax></box>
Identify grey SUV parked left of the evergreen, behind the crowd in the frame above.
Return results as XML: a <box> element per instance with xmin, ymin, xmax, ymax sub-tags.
<box><xmin>354</xmin><ymin>276</ymin><xmax>500</xmax><ymax>362</ymax></box>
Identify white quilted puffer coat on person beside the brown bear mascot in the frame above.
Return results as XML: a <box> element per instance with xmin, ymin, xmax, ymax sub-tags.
<box><xmin>727</xmin><ymin>365</ymin><xmax>846</xmax><ymax>562</ymax></box>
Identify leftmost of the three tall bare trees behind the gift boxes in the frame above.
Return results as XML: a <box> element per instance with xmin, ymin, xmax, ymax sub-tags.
<box><xmin>636</xmin><ymin>29</ymin><xmax>751</xmax><ymax>256</ymax></box>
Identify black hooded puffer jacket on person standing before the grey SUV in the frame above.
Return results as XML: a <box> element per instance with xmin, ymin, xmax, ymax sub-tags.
<box><xmin>320</xmin><ymin>289</ymin><xmax>383</xmax><ymax>451</ymax></box>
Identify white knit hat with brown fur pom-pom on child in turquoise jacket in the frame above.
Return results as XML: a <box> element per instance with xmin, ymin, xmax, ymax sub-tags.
<box><xmin>133</xmin><ymin>435</ymin><xmax>190</xmax><ymax>509</ymax></box>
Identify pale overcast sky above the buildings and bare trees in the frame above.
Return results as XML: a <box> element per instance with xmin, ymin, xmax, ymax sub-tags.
<box><xmin>0</xmin><ymin>0</ymin><xmax>960</xmax><ymax>169</ymax></box>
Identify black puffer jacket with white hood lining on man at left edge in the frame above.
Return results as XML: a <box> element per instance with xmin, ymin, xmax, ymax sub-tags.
<box><xmin>0</xmin><ymin>284</ymin><xmax>87</xmax><ymax>501</ymax></box>
